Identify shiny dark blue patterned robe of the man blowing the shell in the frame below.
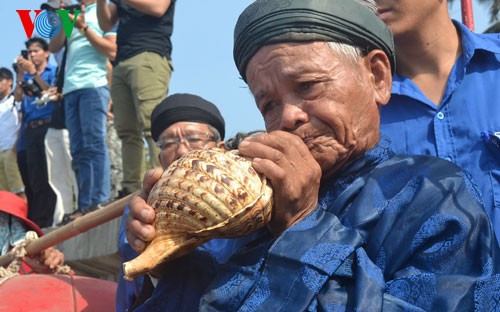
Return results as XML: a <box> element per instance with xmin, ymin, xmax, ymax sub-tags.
<box><xmin>137</xmin><ymin>140</ymin><xmax>500</xmax><ymax>311</ymax></box>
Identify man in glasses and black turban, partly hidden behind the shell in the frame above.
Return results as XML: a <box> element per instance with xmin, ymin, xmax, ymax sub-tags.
<box><xmin>116</xmin><ymin>93</ymin><xmax>232</xmax><ymax>311</ymax></box>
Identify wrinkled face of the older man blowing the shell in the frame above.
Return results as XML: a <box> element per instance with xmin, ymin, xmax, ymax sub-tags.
<box><xmin>246</xmin><ymin>42</ymin><xmax>384</xmax><ymax>177</ymax></box>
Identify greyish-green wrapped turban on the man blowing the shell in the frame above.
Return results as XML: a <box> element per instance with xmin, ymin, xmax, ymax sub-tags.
<box><xmin>233</xmin><ymin>0</ymin><xmax>396</xmax><ymax>81</ymax></box>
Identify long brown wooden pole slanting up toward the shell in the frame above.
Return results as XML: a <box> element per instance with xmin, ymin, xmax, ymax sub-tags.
<box><xmin>0</xmin><ymin>192</ymin><xmax>137</xmax><ymax>266</ymax></box>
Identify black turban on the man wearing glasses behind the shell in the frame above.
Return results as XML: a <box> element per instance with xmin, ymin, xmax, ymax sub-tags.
<box><xmin>151</xmin><ymin>93</ymin><xmax>225</xmax><ymax>141</ymax></box>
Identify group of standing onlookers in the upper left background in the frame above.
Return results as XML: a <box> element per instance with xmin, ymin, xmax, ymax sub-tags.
<box><xmin>1</xmin><ymin>0</ymin><xmax>175</xmax><ymax>228</ymax></box>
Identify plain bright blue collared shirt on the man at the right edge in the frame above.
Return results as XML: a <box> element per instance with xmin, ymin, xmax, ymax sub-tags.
<box><xmin>381</xmin><ymin>22</ymin><xmax>500</xmax><ymax>241</ymax></box>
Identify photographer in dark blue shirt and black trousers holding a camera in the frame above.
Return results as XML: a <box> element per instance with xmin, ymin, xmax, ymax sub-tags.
<box><xmin>15</xmin><ymin>38</ymin><xmax>57</xmax><ymax>228</ymax></box>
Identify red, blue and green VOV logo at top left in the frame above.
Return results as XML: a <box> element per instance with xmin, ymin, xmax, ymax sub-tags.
<box><xmin>16</xmin><ymin>10</ymin><xmax>81</xmax><ymax>39</ymax></box>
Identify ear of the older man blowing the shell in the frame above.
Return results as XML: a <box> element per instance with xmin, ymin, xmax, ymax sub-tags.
<box><xmin>365</xmin><ymin>50</ymin><xmax>392</xmax><ymax>105</ymax></box>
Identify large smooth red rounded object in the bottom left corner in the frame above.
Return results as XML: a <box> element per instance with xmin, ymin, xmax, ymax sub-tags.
<box><xmin>0</xmin><ymin>274</ymin><xmax>116</xmax><ymax>312</ymax></box>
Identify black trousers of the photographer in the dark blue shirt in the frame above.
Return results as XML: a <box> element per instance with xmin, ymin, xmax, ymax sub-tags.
<box><xmin>24</xmin><ymin>125</ymin><xmax>57</xmax><ymax>228</ymax></box>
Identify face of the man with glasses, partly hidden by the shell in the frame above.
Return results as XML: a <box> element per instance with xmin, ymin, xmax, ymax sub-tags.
<box><xmin>157</xmin><ymin>121</ymin><xmax>218</xmax><ymax>169</ymax></box>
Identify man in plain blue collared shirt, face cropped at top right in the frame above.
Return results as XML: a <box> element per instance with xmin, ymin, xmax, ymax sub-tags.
<box><xmin>377</xmin><ymin>0</ymin><xmax>500</xmax><ymax>238</ymax></box>
